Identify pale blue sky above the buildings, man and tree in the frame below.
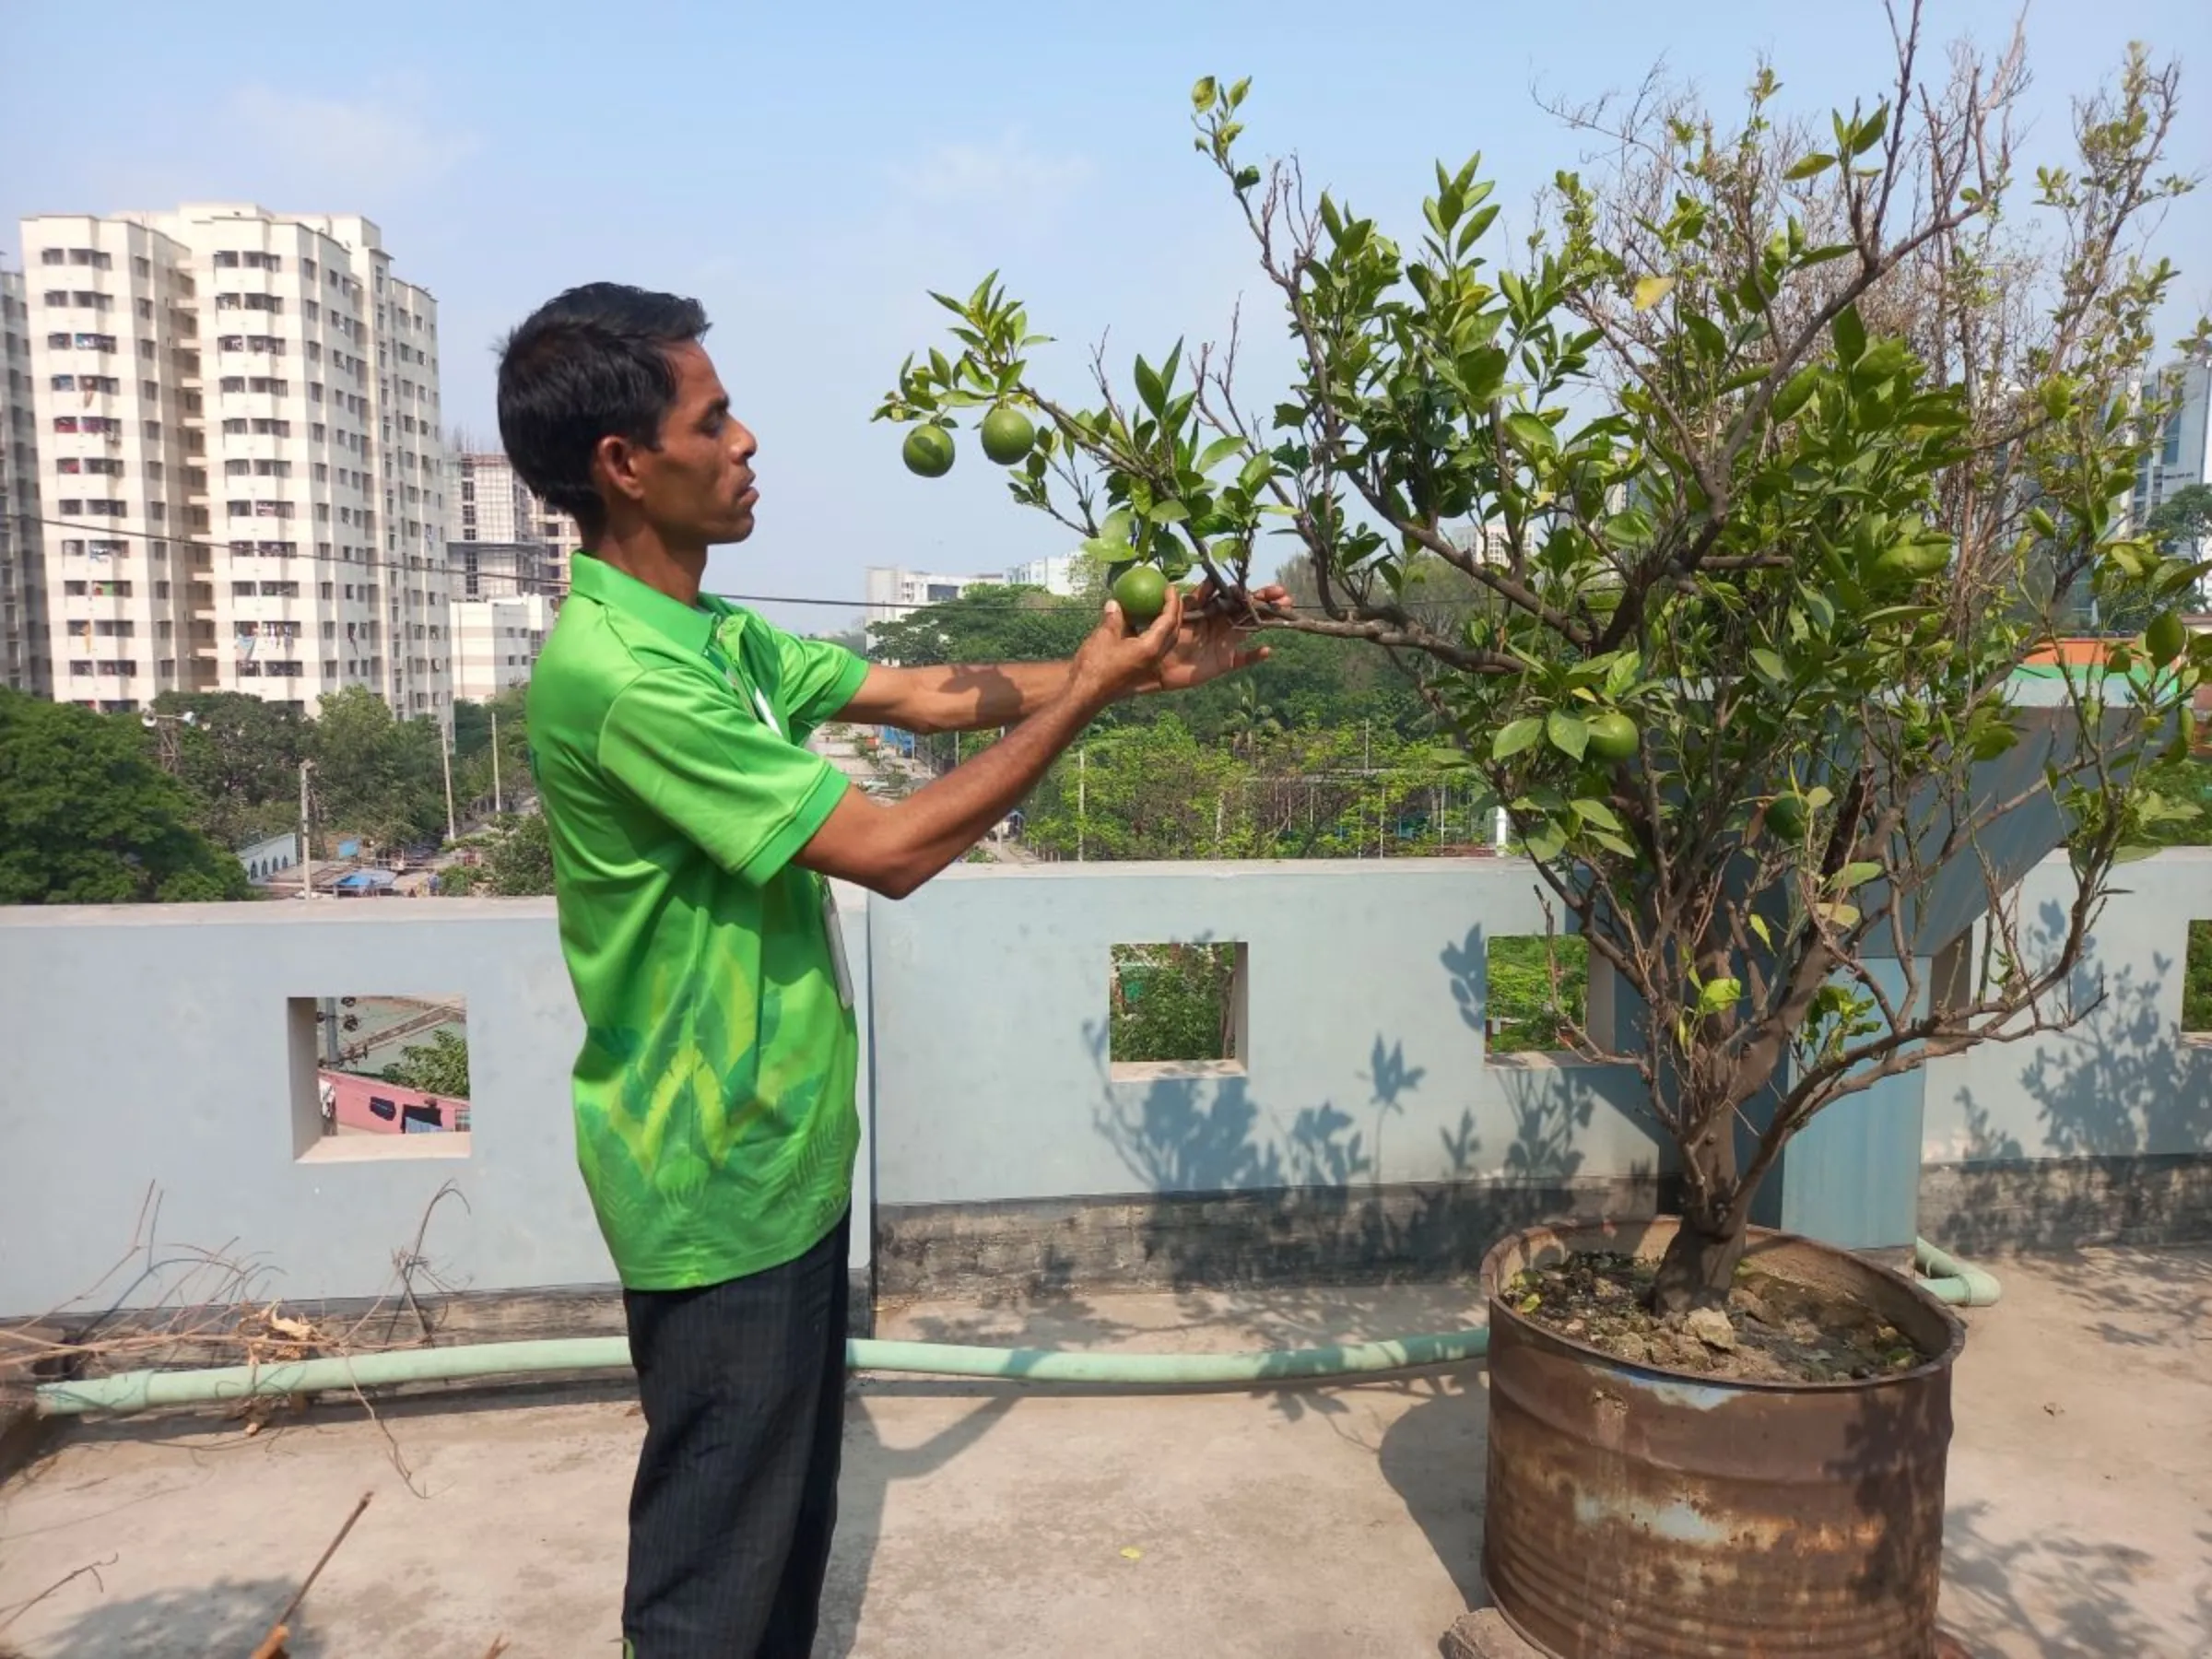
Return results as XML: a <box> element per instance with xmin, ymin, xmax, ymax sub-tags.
<box><xmin>0</xmin><ymin>0</ymin><xmax>2212</xmax><ymax>629</ymax></box>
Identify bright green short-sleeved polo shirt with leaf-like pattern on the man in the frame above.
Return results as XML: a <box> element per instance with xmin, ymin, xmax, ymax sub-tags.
<box><xmin>529</xmin><ymin>555</ymin><xmax>867</xmax><ymax>1289</ymax></box>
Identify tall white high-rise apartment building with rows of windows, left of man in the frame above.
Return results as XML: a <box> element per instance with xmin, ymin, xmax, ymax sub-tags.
<box><xmin>22</xmin><ymin>204</ymin><xmax>453</xmax><ymax>724</ymax></box>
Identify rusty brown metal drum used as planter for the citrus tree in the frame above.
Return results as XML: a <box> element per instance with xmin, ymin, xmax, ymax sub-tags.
<box><xmin>1482</xmin><ymin>1218</ymin><xmax>1964</xmax><ymax>1659</ymax></box>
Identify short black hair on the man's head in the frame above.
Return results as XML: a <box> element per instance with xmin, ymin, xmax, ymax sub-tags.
<box><xmin>500</xmin><ymin>283</ymin><xmax>708</xmax><ymax>537</ymax></box>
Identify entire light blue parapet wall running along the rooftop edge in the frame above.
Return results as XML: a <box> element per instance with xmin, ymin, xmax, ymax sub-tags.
<box><xmin>0</xmin><ymin>852</ymin><xmax>2212</xmax><ymax>1316</ymax></box>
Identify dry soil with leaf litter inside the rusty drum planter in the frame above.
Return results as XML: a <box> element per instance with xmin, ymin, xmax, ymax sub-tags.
<box><xmin>1504</xmin><ymin>1254</ymin><xmax>1929</xmax><ymax>1382</ymax></box>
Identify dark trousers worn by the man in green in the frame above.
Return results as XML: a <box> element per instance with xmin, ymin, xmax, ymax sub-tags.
<box><xmin>621</xmin><ymin>1217</ymin><xmax>852</xmax><ymax>1659</ymax></box>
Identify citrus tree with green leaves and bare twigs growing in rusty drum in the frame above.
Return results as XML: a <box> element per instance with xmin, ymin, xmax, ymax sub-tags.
<box><xmin>878</xmin><ymin>13</ymin><xmax>2212</xmax><ymax>1310</ymax></box>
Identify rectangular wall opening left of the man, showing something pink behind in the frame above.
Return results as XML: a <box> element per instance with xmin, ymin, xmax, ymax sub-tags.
<box><xmin>286</xmin><ymin>994</ymin><xmax>471</xmax><ymax>1161</ymax></box>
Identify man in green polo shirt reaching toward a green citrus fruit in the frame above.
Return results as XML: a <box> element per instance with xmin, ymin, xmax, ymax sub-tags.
<box><xmin>484</xmin><ymin>283</ymin><xmax>1283</xmax><ymax>1659</ymax></box>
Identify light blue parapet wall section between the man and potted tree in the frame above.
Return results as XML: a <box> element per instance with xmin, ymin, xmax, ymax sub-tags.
<box><xmin>869</xmin><ymin>858</ymin><xmax>1659</xmax><ymax>1204</ymax></box>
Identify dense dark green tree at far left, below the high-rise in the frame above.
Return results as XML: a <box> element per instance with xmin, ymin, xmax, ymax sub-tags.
<box><xmin>0</xmin><ymin>690</ymin><xmax>253</xmax><ymax>905</ymax></box>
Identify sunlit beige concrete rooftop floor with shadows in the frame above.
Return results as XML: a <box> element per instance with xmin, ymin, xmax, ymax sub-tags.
<box><xmin>0</xmin><ymin>1250</ymin><xmax>2212</xmax><ymax>1659</ymax></box>
